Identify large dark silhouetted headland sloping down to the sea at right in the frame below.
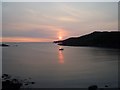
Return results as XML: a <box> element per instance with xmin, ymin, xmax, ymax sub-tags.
<box><xmin>54</xmin><ymin>31</ymin><xmax>120</xmax><ymax>49</ymax></box>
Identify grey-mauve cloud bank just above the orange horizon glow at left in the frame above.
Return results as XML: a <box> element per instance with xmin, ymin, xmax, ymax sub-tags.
<box><xmin>3</xmin><ymin>23</ymin><xmax>68</xmax><ymax>39</ymax></box>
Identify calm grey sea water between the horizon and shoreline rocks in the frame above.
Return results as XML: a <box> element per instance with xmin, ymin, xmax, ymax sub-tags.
<box><xmin>2</xmin><ymin>43</ymin><xmax>119</xmax><ymax>88</ymax></box>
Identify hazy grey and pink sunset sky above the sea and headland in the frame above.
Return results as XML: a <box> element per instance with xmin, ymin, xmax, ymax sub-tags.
<box><xmin>0</xmin><ymin>2</ymin><xmax>118</xmax><ymax>42</ymax></box>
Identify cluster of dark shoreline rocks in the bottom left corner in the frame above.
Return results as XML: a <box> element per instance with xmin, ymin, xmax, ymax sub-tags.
<box><xmin>2</xmin><ymin>74</ymin><xmax>35</xmax><ymax>90</ymax></box>
